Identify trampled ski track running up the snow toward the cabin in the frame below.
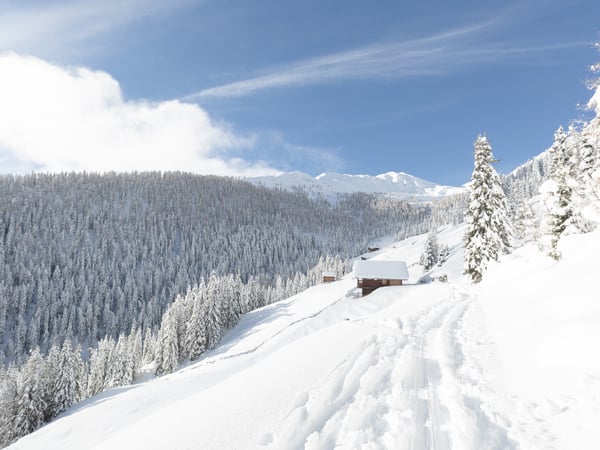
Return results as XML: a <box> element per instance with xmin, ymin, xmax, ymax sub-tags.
<box><xmin>260</xmin><ymin>286</ymin><xmax>536</xmax><ymax>450</ymax></box>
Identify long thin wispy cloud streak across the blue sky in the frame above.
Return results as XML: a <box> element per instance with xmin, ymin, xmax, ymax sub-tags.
<box><xmin>189</xmin><ymin>11</ymin><xmax>589</xmax><ymax>100</ymax></box>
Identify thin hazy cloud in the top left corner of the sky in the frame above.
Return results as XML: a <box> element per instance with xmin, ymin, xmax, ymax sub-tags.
<box><xmin>0</xmin><ymin>0</ymin><xmax>189</xmax><ymax>58</ymax></box>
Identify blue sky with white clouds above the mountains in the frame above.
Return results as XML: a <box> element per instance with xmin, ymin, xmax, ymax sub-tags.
<box><xmin>0</xmin><ymin>0</ymin><xmax>600</xmax><ymax>185</ymax></box>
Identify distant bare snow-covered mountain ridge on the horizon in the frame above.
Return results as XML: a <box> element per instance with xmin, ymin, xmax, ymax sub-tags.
<box><xmin>249</xmin><ymin>172</ymin><xmax>465</xmax><ymax>200</ymax></box>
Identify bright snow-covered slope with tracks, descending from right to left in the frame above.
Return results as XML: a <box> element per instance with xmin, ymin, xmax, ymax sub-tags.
<box><xmin>11</xmin><ymin>227</ymin><xmax>600</xmax><ymax>450</ymax></box>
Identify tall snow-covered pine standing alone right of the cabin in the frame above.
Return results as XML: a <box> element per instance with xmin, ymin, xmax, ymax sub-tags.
<box><xmin>464</xmin><ymin>135</ymin><xmax>510</xmax><ymax>283</ymax></box>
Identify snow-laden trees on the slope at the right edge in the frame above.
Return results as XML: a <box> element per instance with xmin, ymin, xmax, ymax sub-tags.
<box><xmin>504</xmin><ymin>114</ymin><xmax>600</xmax><ymax>250</ymax></box>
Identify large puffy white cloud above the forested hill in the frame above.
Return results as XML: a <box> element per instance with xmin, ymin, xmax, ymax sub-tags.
<box><xmin>0</xmin><ymin>53</ymin><xmax>278</xmax><ymax>176</ymax></box>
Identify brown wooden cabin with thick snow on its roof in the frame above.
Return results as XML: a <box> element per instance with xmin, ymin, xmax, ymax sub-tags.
<box><xmin>352</xmin><ymin>260</ymin><xmax>408</xmax><ymax>296</ymax></box>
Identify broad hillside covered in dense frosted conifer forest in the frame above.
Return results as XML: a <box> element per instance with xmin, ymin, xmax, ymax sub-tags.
<box><xmin>0</xmin><ymin>172</ymin><xmax>429</xmax><ymax>366</ymax></box>
